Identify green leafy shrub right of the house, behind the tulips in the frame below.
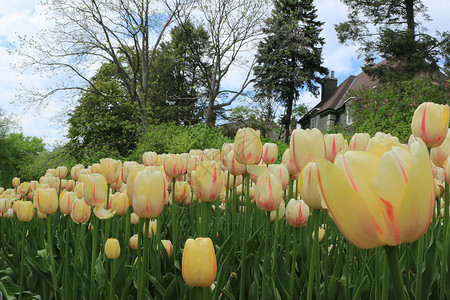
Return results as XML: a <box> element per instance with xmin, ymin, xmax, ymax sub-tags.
<box><xmin>342</xmin><ymin>76</ymin><xmax>450</xmax><ymax>143</ymax></box>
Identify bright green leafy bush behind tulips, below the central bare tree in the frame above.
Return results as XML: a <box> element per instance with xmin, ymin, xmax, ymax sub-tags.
<box><xmin>129</xmin><ymin>123</ymin><xmax>230</xmax><ymax>162</ymax></box>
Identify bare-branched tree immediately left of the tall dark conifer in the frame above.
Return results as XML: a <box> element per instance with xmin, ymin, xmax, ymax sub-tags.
<box><xmin>177</xmin><ymin>0</ymin><xmax>269</xmax><ymax>126</ymax></box>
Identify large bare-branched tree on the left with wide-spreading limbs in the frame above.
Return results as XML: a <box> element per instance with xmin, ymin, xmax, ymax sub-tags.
<box><xmin>17</xmin><ymin>0</ymin><xmax>191</xmax><ymax>133</ymax></box>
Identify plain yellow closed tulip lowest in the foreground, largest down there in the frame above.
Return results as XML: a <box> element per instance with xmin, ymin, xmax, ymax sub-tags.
<box><xmin>182</xmin><ymin>238</ymin><xmax>217</xmax><ymax>287</ymax></box>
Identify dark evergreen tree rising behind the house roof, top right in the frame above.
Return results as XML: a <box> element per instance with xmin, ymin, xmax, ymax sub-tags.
<box><xmin>335</xmin><ymin>0</ymin><xmax>450</xmax><ymax>81</ymax></box>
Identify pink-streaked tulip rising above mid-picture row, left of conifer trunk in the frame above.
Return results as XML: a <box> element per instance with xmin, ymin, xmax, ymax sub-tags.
<box><xmin>233</xmin><ymin>128</ymin><xmax>262</xmax><ymax>165</ymax></box>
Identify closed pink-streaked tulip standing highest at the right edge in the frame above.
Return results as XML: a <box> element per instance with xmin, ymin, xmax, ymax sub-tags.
<box><xmin>411</xmin><ymin>102</ymin><xmax>449</xmax><ymax>148</ymax></box>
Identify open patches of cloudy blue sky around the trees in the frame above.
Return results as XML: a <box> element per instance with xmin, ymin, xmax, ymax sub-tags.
<box><xmin>0</xmin><ymin>0</ymin><xmax>450</xmax><ymax>148</ymax></box>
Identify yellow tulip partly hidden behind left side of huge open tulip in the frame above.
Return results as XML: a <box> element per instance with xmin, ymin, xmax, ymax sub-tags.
<box><xmin>298</xmin><ymin>162</ymin><xmax>323</xmax><ymax>210</ymax></box>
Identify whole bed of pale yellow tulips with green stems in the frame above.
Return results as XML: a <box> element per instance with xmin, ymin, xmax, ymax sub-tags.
<box><xmin>0</xmin><ymin>103</ymin><xmax>450</xmax><ymax>300</ymax></box>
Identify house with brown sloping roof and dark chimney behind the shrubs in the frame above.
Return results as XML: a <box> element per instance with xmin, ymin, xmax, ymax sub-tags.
<box><xmin>297</xmin><ymin>62</ymin><xmax>378</xmax><ymax>132</ymax></box>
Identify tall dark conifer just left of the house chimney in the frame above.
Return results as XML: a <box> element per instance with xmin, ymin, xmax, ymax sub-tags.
<box><xmin>254</xmin><ymin>0</ymin><xmax>328</xmax><ymax>143</ymax></box>
